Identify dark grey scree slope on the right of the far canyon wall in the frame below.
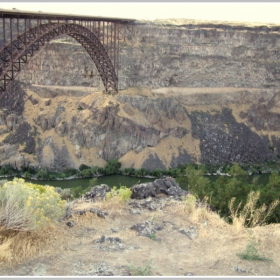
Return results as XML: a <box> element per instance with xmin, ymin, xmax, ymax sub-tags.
<box><xmin>189</xmin><ymin>108</ymin><xmax>276</xmax><ymax>164</ymax></box>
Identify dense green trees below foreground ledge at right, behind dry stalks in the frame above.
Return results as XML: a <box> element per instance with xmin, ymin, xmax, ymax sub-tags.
<box><xmin>181</xmin><ymin>165</ymin><xmax>280</xmax><ymax>227</ymax></box>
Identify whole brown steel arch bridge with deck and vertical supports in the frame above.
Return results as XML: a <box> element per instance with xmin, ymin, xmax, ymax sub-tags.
<box><xmin>0</xmin><ymin>10</ymin><xmax>134</xmax><ymax>98</ymax></box>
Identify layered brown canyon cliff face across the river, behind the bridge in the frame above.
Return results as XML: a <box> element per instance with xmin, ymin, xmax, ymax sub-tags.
<box><xmin>0</xmin><ymin>20</ymin><xmax>280</xmax><ymax>170</ymax></box>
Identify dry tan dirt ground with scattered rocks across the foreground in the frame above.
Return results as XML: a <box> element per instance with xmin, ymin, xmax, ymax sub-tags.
<box><xmin>0</xmin><ymin>200</ymin><xmax>280</xmax><ymax>277</ymax></box>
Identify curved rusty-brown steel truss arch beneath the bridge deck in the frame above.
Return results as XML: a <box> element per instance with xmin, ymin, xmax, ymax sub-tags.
<box><xmin>0</xmin><ymin>23</ymin><xmax>118</xmax><ymax>97</ymax></box>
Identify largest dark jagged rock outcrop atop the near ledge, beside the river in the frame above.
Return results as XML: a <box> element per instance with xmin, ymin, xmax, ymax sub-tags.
<box><xmin>130</xmin><ymin>177</ymin><xmax>188</xmax><ymax>199</ymax></box>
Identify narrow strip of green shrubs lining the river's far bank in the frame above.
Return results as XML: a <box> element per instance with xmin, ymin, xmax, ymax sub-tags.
<box><xmin>0</xmin><ymin>160</ymin><xmax>280</xmax><ymax>184</ymax></box>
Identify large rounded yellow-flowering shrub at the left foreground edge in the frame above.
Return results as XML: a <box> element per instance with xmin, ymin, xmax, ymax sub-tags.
<box><xmin>0</xmin><ymin>178</ymin><xmax>65</xmax><ymax>231</ymax></box>
